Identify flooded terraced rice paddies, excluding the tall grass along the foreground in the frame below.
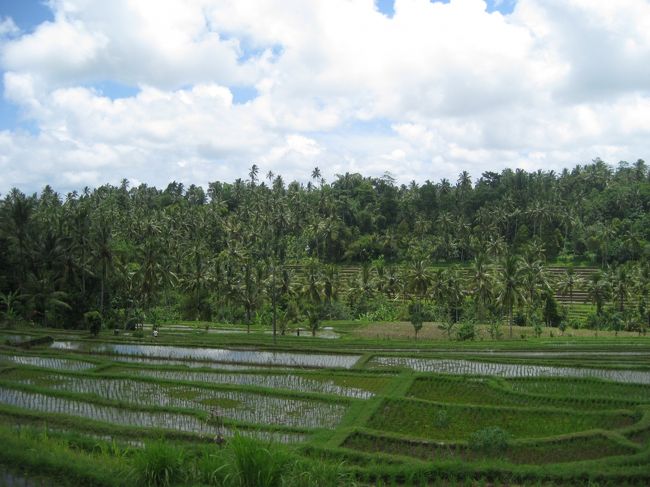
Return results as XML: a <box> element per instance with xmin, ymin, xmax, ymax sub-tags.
<box><xmin>0</xmin><ymin>333</ymin><xmax>650</xmax><ymax>485</ymax></box>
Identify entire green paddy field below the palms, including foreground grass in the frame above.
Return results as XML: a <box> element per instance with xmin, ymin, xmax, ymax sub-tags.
<box><xmin>0</xmin><ymin>322</ymin><xmax>650</xmax><ymax>486</ymax></box>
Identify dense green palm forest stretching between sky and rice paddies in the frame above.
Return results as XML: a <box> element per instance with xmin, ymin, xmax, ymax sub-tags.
<box><xmin>0</xmin><ymin>160</ymin><xmax>650</xmax><ymax>338</ymax></box>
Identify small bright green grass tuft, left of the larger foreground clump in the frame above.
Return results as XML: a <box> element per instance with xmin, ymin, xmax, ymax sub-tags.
<box><xmin>132</xmin><ymin>440</ymin><xmax>187</xmax><ymax>487</ymax></box>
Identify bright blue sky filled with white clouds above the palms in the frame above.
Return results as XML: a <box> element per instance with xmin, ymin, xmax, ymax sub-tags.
<box><xmin>0</xmin><ymin>0</ymin><xmax>650</xmax><ymax>195</ymax></box>
